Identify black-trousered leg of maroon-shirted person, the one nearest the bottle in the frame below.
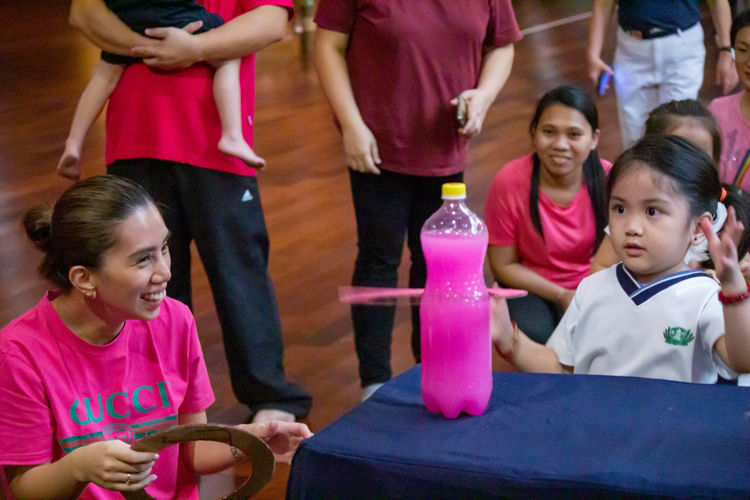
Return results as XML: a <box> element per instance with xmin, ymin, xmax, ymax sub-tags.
<box><xmin>407</xmin><ymin>172</ymin><xmax>464</xmax><ymax>363</ymax></box>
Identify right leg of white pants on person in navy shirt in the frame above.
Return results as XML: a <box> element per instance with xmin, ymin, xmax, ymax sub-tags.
<box><xmin>654</xmin><ymin>23</ymin><xmax>706</xmax><ymax>104</ymax></box>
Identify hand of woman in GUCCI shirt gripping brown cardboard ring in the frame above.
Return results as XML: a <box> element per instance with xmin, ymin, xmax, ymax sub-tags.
<box><xmin>70</xmin><ymin>440</ymin><xmax>159</xmax><ymax>491</ymax></box>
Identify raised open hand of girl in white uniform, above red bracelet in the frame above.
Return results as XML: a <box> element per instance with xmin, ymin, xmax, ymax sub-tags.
<box><xmin>700</xmin><ymin>207</ymin><xmax>747</xmax><ymax>291</ymax></box>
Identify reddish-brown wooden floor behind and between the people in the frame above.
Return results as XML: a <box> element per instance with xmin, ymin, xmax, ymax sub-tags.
<box><xmin>0</xmin><ymin>0</ymin><xmax>728</xmax><ymax>499</ymax></box>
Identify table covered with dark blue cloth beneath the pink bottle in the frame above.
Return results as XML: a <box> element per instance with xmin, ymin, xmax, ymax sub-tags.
<box><xmin>286</xmin><ymin>365</ymin><xmax>750</xmax><ymax>500</ymax></box>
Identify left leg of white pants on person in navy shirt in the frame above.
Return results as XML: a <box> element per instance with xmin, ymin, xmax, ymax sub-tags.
<box><xmin>614</xmin><ymin>27</ymin><xmax>659</xmax><ymax>148</ymax></box>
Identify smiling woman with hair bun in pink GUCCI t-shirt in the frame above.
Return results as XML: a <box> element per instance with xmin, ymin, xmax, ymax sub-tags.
<box><xmin>0</xmin><ymin>176</ymin><xmax>312</xmax><ymax>500</ymax></box>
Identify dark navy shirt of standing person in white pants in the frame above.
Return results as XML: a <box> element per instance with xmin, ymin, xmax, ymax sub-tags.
<box><xmin>617</xmin><ymin>0</ymin><xmax>701</xmax><ymax>32</ymax></box>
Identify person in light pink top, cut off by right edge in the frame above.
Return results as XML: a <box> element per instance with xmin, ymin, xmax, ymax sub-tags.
<box><xmin>709</xmin><ymin>11</ymin><xmax>750</xmax><ymax>191</ymax></box>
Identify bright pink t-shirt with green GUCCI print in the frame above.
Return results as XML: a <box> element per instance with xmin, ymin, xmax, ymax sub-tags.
<box><xmin>0</xmin><ymin>291</ymin><xmax>214</xmax><ymax>500</ymax></box>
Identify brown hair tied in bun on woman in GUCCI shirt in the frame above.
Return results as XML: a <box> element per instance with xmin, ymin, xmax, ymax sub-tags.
<box><xmin>23</xmin><ymin>175</ymin><xmax>155</xmax><ymax>291</ymax></box>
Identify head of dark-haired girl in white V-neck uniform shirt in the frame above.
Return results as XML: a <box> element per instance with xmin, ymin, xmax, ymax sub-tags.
<box><xmin>607</xmin><ymin>135</ymin><xmax>721</xmax><ymax>283</ymax></box>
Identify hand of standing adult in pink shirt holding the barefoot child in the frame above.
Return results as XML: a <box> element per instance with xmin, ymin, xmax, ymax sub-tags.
<box><xmin>131</xmin><ymin>21</ymin><xmax>203</xmax><ymax>69</ymax></box>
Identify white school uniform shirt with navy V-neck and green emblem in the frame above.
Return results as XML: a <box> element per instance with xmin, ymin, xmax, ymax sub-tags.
<box><xmin>547</xmin><ymin>263</ymin><xmax>737</xmax><ymax>384</ymax></box>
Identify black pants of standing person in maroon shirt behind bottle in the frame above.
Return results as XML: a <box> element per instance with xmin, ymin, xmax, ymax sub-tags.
<box><xmin>350</xmin><ymin>170</ymin><xmax>463</xmax><ymax>387</ymax></box>
